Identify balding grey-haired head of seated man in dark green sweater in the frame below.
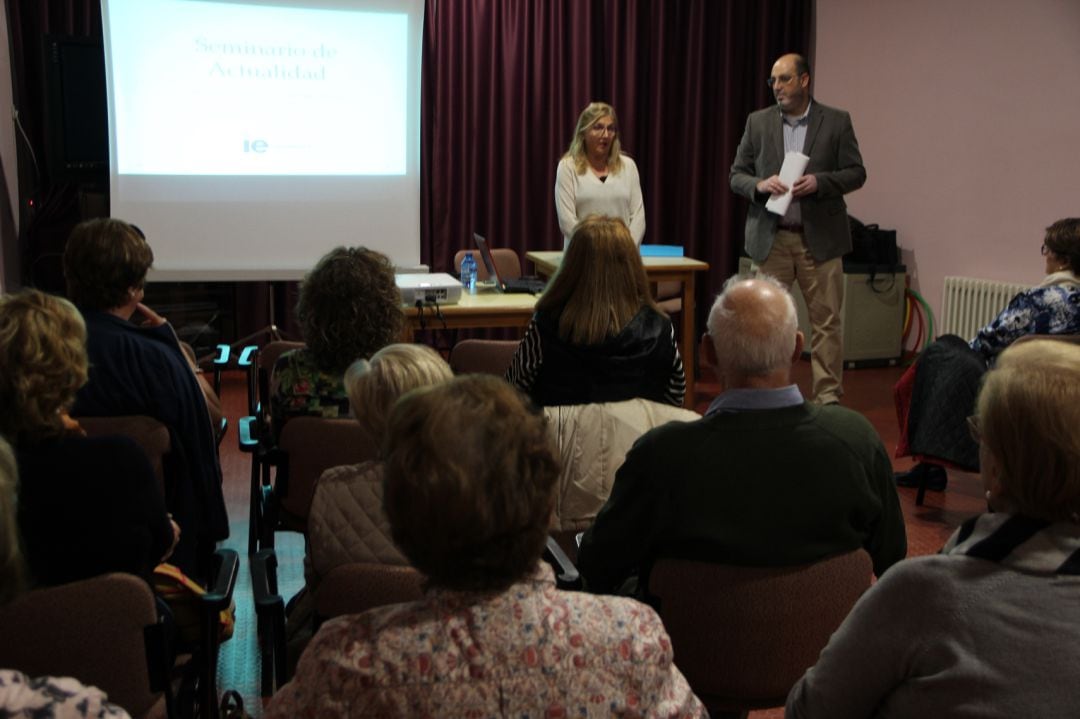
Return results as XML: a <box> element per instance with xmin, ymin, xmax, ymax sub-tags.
<box><xmin>708</xmin><ymin>275</ymin><xmax>800</xmax><ymax>383</ymax></box>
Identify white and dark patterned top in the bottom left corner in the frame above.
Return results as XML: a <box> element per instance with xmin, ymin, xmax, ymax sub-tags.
<box><xmin>0</xmin><ymin>669</ymin><xmax>131</xmax><ymax>719</ymax></box>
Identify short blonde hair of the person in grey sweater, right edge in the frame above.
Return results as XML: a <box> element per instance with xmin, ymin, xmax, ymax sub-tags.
<box><xmin>977</xmin><ymin>340</ymin><xmax>1080</xmax><ymax>524</ymax></box>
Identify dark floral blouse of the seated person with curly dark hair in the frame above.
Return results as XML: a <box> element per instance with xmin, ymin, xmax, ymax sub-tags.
<box><xmin>270</xmin><ymin>348</ymin><xmax>352</xmax><ymax>432</ymax></box>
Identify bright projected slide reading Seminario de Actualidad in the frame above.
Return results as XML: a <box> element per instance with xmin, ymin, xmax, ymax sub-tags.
<box><xmin>108</xmin><ymin>0</ymin><xmax>409</xmax><ymax>176</ymax></box>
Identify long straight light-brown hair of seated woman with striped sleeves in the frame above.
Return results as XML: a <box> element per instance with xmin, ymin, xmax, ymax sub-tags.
<box><xmin>537</xmin><ymin>215</ymin><xmax>660</xmax><ymax>344</ymax></box>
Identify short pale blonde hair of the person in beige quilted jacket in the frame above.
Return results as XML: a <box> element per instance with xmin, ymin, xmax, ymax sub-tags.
<box><xmin>345</xmin><ymin>344</ymin><xmax>454</xmax><ymax>444</ymax></box>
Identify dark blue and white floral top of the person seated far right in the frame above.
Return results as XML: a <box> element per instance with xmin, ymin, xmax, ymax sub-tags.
<box><xmin>971</xmin><ymin>272</ymin><xmax>1080</xmax><ymax>363</ymax></box>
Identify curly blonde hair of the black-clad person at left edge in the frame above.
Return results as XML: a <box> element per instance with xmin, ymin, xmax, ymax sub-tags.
<box><xmin>0</xmin><ymin>289</ymin><xmax>86</xmax><ymax>444</ymax></box>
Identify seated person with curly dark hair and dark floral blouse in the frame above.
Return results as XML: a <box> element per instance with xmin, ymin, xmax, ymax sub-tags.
<box><xmin>270</xmin><ymin>247</ymin><xmax>405</xmax><ymax>433</ymax></box>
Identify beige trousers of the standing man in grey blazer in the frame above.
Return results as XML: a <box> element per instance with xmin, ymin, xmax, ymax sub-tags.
<box><xmin>753</xmin><ymin>229</ymin><xmax>843</xmax><ymax>405</ymax></box>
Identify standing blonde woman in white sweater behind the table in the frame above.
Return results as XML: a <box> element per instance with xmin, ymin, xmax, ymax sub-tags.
<box><xmin>555</xmin><ymin>103</ymin><xmax>645</xmax><ymax>246</ymax></box>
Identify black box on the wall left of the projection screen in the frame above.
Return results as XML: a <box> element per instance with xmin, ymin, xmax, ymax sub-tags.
<box><xmin>44</xmin><ymin>35</ymin><xmax>109</xmax><ymax>192</ymax></box>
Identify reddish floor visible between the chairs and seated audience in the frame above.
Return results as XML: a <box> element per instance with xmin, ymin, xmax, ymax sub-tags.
<box><xmin>210</xmin><ymin>362</ymin><xmax>985</xmax><ymax>719</ymax></box>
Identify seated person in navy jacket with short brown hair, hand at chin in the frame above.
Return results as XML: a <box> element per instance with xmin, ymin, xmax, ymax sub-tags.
<box><xmin>64</xmin><ymin>219</ymin><xmax>229</xmax><ymax>576</ymax></box>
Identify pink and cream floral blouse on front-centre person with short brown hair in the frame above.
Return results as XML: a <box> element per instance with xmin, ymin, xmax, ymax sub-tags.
<box><xmin>267</xmin><ymin>564</ymin><xmax>707</xmax><ymax>719</ymax></box>
